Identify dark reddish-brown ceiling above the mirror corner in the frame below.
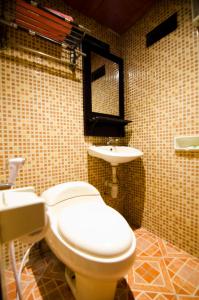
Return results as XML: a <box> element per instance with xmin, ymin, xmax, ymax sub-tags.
<box><xmin>64</xmin><ymin>0</ymin><xmax>154</xmax><ymax>34</ymax></box>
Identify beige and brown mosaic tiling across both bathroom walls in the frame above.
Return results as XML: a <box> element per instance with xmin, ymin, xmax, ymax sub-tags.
<box><xmin>0</xmin><ymin>0</ymin><xmax>199</xmax><ymax>262</ymax></box>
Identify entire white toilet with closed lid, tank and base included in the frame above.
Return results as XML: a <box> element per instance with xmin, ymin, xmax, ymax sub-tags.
<box><xmin>42</xmin><ymin>181</ymin><xmax>136</xmax><ymax>300</ymax></box>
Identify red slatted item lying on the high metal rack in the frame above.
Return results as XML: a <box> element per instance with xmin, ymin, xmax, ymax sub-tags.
<box><xmin>16</xmin><ymin>0</ymin><xmax>73</xmax><ymax>42</ymax></box>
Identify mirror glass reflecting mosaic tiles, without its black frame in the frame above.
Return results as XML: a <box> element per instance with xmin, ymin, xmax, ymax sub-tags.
<box><xmin>91</xmin><ymin>52</ymin><xmax>119</xmax><ymax>116</ymax></box>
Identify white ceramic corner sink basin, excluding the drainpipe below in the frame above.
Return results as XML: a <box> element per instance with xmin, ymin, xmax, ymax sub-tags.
<box><xmin>88</xmin><ymin>146</ymin><xmax>143</xmax><ymax>166</ymax></box>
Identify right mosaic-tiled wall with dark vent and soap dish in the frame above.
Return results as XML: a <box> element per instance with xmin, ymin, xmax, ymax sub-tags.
<box><xmin>123</xmin><ymin>0</ymin><xmax>199</xmax><ymax>256</ymax></box>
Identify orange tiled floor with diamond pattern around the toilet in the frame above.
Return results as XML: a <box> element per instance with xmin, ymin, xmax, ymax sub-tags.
<box><xmin>6</xmin><ymin>228</ymin><xmax>199</xmax><ymax>300</ymax></box>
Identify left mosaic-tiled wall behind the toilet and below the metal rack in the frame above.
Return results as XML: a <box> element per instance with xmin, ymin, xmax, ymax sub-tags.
<box><xmin>0</xmin><ymin>0</ymin><xmax>122</xmax><ymax>264</ymax></box>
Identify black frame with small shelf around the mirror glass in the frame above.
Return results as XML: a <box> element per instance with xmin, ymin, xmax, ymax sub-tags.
<box><xmin>82</xmin><ymin>39</ymin><xmax>129</xmax><ymax>137</ymax></box>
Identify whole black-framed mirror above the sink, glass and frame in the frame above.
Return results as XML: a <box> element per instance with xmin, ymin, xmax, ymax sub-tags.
<box><xmin>82</xmin><ymin>35</ymin><xmax>129</xmax><ymax>136</ymax></box>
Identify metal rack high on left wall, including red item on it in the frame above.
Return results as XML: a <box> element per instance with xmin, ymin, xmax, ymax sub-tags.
<box><xmin>0</xmin><ymin>0</ymin><xmax>89</xmax><ymax>69</ymax></box>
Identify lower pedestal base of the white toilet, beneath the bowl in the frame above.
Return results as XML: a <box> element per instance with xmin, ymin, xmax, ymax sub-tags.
<box><xmin>65</xmin><ymin>267</ymin><xmax>117</xmax><ymax>300</ymax></box>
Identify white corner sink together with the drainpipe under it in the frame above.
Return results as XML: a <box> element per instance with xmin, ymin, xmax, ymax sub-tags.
<box><xmin>88</xmin><ymin>146</ymin><xmax>143</xmax><ymax>198</ymax></box>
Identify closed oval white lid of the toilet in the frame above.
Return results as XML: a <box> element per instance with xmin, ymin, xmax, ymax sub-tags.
<box><xmin>58</xmin><ymin>203</ymin><xmax>133</xmax><ymax>257</ymax></box>
